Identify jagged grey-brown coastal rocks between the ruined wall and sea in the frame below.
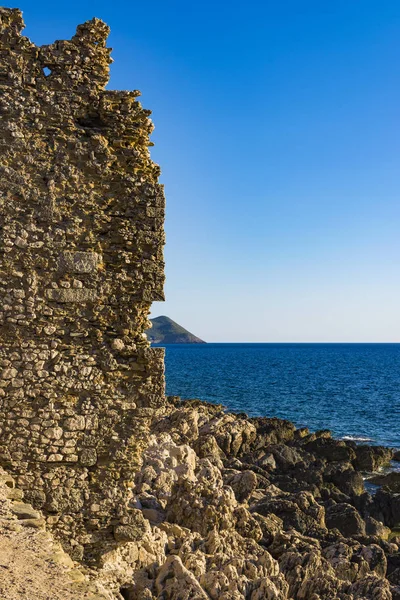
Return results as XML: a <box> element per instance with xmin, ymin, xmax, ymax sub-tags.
<box><xmin>90</xmin><ymin>397</ymin><xmax>400</xmax><ymax>600</ymax></box>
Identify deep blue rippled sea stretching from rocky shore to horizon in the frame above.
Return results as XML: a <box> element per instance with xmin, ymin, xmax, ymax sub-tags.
<box><xmin>157</xmin><ymin>344</ymin><xmax>400</xmax><ymax>447</ymax></box>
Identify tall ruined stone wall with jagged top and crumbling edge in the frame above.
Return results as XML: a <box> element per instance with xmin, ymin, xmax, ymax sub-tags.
<box><xmin>0</xmin><ymin>9</ymin><xmax>164</xmax><ymax>557</ymax></box>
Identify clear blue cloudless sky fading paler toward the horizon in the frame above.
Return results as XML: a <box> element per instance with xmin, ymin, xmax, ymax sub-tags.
<box><xmin>14</xmin><ymin>0</ymin><xmax>400</xmax><ymax>342</ymax></box>
